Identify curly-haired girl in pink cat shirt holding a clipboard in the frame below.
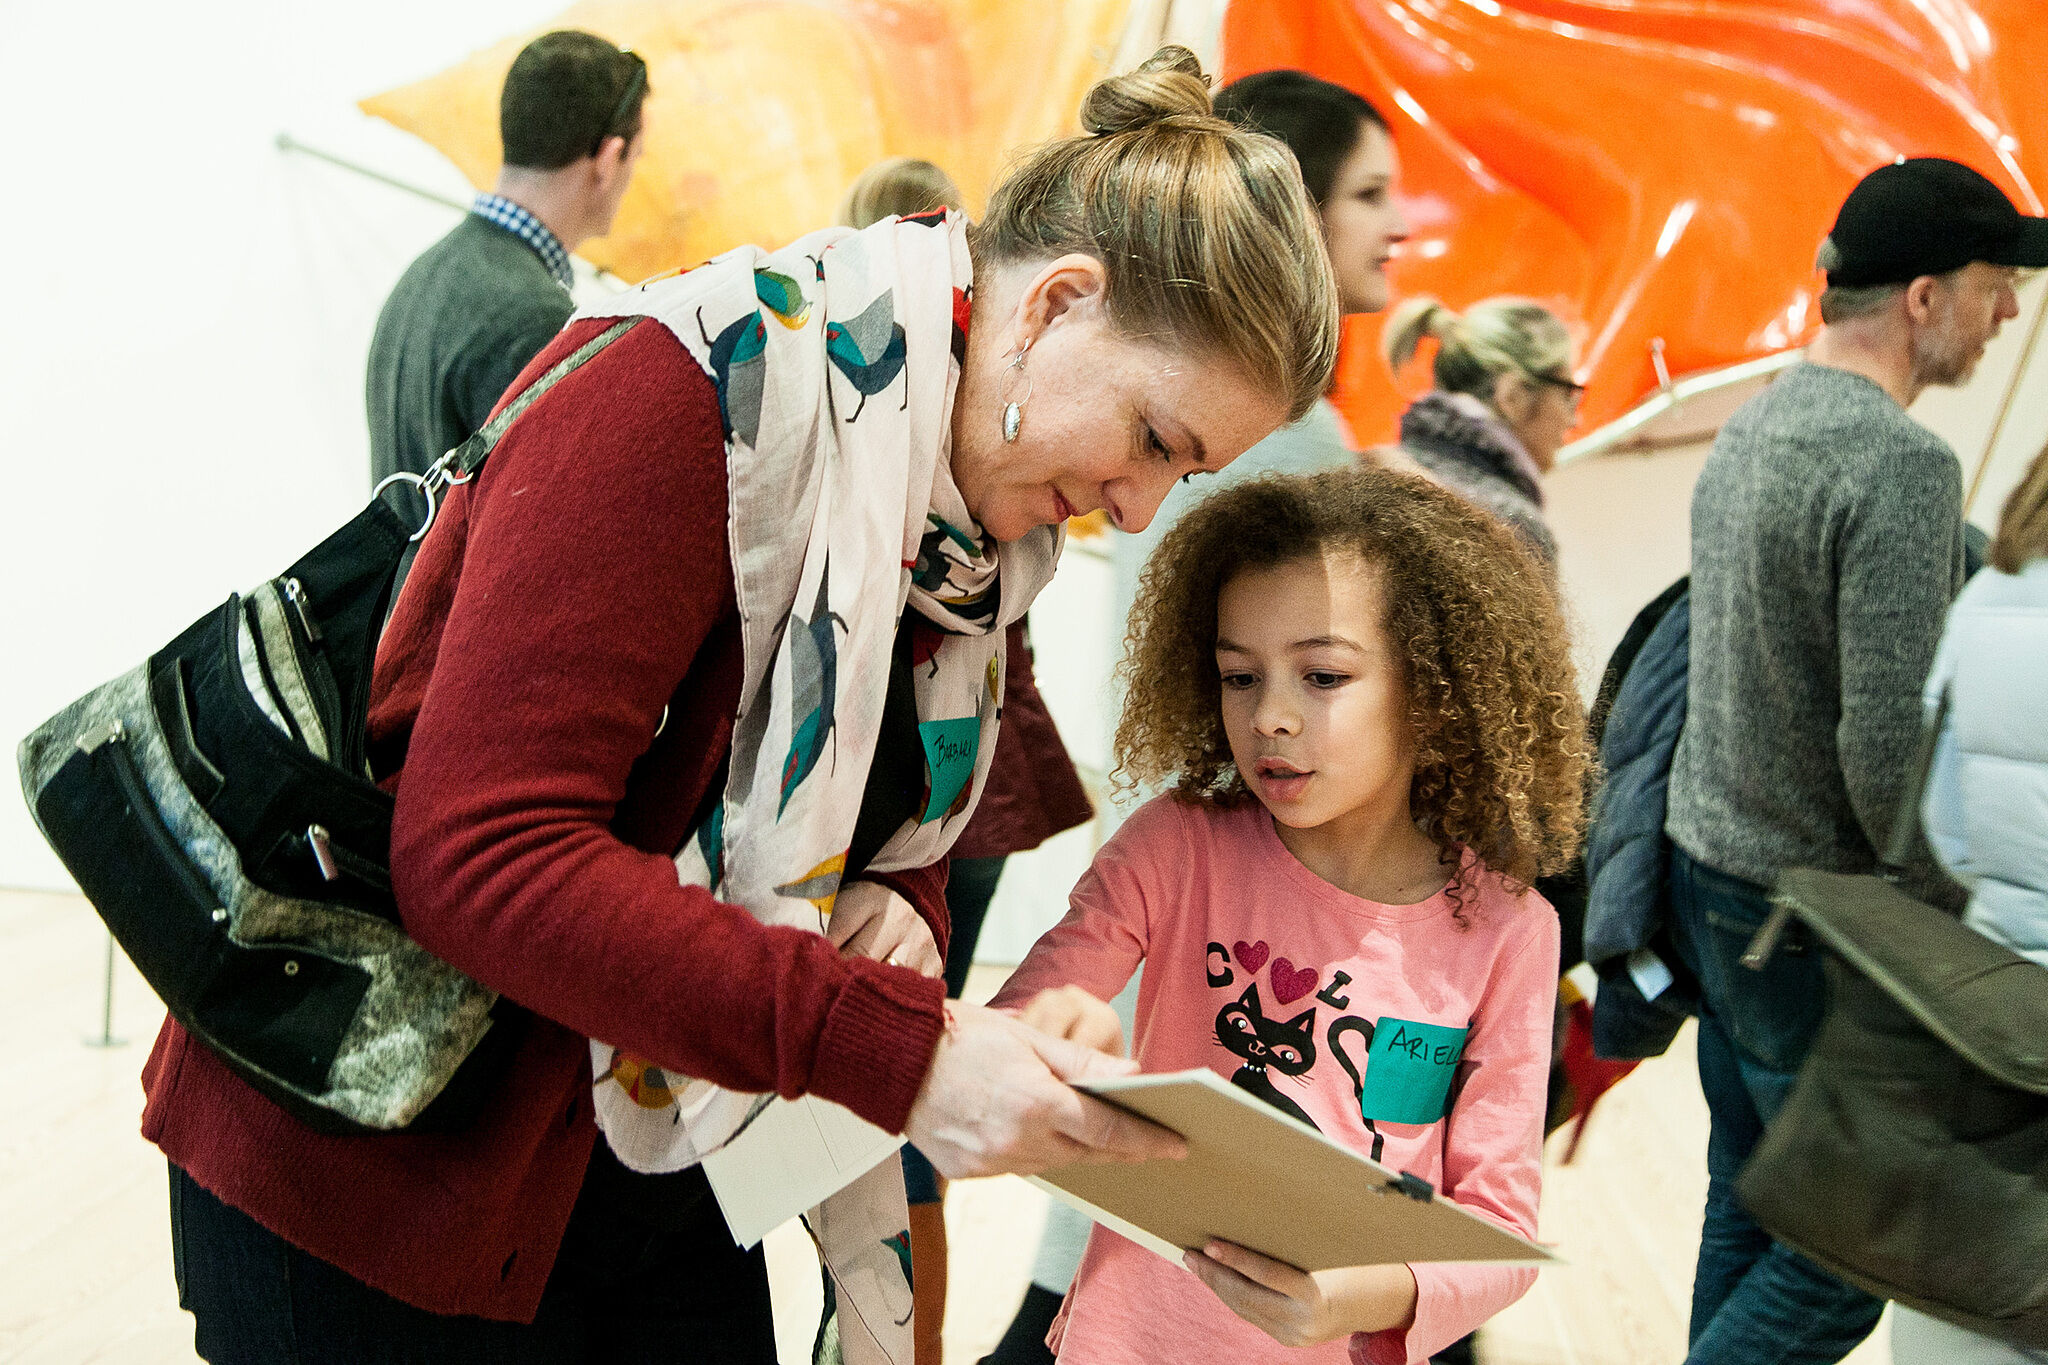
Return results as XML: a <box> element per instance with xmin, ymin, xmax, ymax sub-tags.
<box><xmin>995</xmin><ymin>467</ymin><xmax>1587</xmax><ymax>1365</ymax></box>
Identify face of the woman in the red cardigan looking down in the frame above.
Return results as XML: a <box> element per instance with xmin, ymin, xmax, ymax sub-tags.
<box><xmin>952</xmin><ymin>256</ymin><xmax>1286</xmax><ymax>540</ymax></box>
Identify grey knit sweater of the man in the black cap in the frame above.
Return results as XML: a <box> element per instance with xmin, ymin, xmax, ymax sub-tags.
<box><xmin>1665</xmin><ymin>364</ymin><xmax>1962</xmax><ymax>886</ymax></box>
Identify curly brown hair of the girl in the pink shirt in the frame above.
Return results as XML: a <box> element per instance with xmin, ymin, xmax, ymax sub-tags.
<box><xmin>1116</xmin><ymin>465</ymin><xmax>1591</xmax><ymax>888</ymax></box>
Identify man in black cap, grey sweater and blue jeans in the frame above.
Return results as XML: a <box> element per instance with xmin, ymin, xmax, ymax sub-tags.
<box><xmin>1665</xmin><ymin>158</ymin><xmax>2048</xmax><ymax>1365</ymax></box>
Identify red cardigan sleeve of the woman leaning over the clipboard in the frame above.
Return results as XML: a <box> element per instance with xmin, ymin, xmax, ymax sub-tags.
<box><xmin>391</xmin><ymin>323</ymin><xmax>944</xmax><ymax>1132</ymax></box>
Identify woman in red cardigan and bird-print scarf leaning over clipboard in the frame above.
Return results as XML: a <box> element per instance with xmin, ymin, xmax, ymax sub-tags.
<box><xmin>159</xmin><ymin>49</ymin><xmax>1337</xmax><ymax>1365</ymax></box>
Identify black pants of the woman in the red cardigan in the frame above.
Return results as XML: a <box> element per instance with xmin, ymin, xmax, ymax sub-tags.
<box><xmin>170</xmin><ymin>1140</ymin><xmax>774</xmax><ymax>1365</ymax></box>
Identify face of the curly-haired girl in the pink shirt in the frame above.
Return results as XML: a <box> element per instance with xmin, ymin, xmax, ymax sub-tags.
<box><xmin>1217</xmin><ymin>551</ymin><xmax>1415</xmax><ymax>833</ymax></box>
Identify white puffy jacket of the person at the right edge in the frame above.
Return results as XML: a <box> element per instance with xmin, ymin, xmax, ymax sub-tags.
<box><xmin>1921</xmin><ymin>559</ymin><xmax>2048</xmax><ymax>966</ymax></box>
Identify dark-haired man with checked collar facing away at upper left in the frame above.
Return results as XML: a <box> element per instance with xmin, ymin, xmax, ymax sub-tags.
<box><xmin>369</xmin><ymin>31</ymin><xmax>647</xmax><ymax>481</ymax></box>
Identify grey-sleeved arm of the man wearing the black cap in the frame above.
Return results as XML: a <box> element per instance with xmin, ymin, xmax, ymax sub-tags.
<box><xmin>1835</xmin><ymin>439</ymin><xmax>1962</xmax><ymax>900</ymax></box>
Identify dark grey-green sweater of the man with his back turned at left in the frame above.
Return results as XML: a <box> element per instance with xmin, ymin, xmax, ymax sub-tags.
<box><xmin>367</xmin><ymin>215</ymin><xmax>573</xmax><ymax>481</ymax></box>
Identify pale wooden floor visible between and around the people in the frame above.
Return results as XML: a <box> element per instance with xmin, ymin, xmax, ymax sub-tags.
<box><xmin>0</xmin><ymin>890</ymin><xmax>1890</xmax><ymax>1365</ymax></box>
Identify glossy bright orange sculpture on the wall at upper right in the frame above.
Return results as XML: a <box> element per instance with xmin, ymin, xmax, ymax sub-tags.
<box><xmin>1223</xmin><ymin>0</ymin><xmax>2048</xmax><ymax>442</ymax></box>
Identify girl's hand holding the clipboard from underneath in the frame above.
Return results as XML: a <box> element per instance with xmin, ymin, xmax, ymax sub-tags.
<box><xmin>1182</xmin><ymin>1242</ymin><xmax>1415</xmax><ymax>1347</ymax></box>
